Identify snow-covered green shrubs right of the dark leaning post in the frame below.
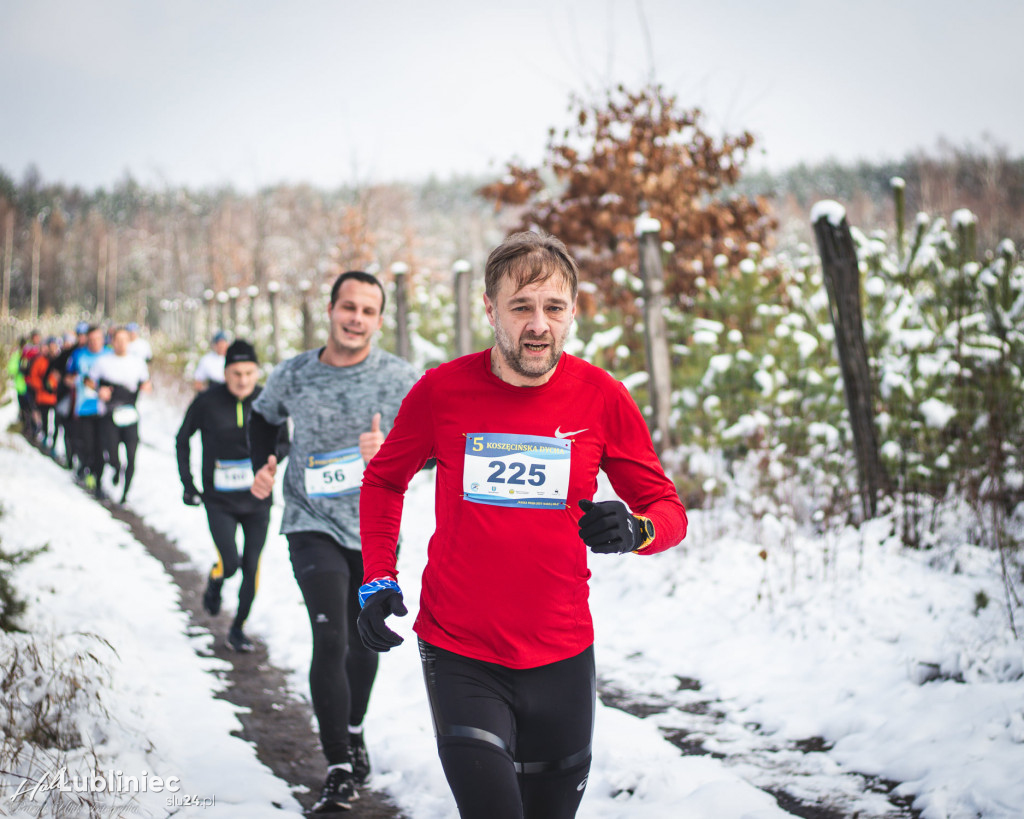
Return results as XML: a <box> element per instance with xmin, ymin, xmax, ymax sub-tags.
<box><xmin>854</xmin><ymin>210</ymin><xmax>1024</xmax><ymax>546</ymax></box>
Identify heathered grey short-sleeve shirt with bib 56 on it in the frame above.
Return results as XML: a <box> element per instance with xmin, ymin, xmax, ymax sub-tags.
<box><xmin>253</xmin><ymin>347</ymin><xmax>417</xmax><ymax>549</ymax></box>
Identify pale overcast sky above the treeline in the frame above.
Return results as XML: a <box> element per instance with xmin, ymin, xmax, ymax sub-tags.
<box><xmin>0</xmin><ymin>0</ymin><xmax>1024</xmax><ymax>188</ymax></box>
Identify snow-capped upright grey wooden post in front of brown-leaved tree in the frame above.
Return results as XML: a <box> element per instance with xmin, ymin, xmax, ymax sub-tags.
<box><xmin>636</xmin><ymin>214</ymin><xmax>672</xmax><ymax>455</ymax></box>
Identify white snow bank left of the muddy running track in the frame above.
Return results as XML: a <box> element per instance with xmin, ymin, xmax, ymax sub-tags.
<box><xmin>0</xmin><ymin>413</ymin><xmax>301</xmax><ymax>819</ymax></box>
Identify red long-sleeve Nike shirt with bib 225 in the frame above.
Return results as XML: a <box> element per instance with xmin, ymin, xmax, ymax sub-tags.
<box><xmin>359</xmin><ymin>350</ymin><xmax>686</xmax><ymax>669</ymax></box>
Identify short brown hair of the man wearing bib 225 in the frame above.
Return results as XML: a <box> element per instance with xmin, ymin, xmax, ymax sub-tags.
<box><xmin>483</xmin><ymin>230</ymin><xmax>580</xmax><ymax>301</ymax></box>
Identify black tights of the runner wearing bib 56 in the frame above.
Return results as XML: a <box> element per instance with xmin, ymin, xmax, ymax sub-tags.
<box><xmin>288</xmin><ymin>531</ymin><xmax>378</xmax><ymax>765</ymax></box>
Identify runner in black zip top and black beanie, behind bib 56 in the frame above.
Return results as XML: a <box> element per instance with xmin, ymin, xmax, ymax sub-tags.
<box><xmin>176</xmin><ymin>340</ymin><xmax>289</xmax><ymax>651</ymax></box>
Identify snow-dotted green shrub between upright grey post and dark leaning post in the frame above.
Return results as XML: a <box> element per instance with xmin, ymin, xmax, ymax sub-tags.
<box><xmin>670</xmin><ymin>247</ymin><xmax>854</xmax><ymax>525</ymax></box>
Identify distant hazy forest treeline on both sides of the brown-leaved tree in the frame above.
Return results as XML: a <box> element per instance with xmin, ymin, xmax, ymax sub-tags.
<box><xmin>0</xmin><ymin>145</ymin><xmax>1024</xmax><ymax>325</ymax></box>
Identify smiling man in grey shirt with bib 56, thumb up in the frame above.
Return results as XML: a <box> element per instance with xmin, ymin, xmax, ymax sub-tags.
<box><xmin>249</xmin><ymin>270</ymin><xmax>417</xmax><ymax>813</ymax></box>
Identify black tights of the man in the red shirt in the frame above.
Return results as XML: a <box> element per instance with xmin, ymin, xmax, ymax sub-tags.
<box><xmin>420</xmin><ymin>640</ymin><xmax>597</xmax><ymax>819</ymax></box>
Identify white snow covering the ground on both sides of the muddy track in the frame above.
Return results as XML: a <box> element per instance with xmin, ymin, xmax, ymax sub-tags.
<box><xmin>0</xmin><ymin>384</ymin><xmax>1024</xmax><ymax>819</ymax></box>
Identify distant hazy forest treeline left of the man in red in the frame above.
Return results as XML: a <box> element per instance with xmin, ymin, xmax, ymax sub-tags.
<box><xmin>0</xmin><ymin>169</ymin><xmax>501</xmax><ymax>327</ymax></box>
